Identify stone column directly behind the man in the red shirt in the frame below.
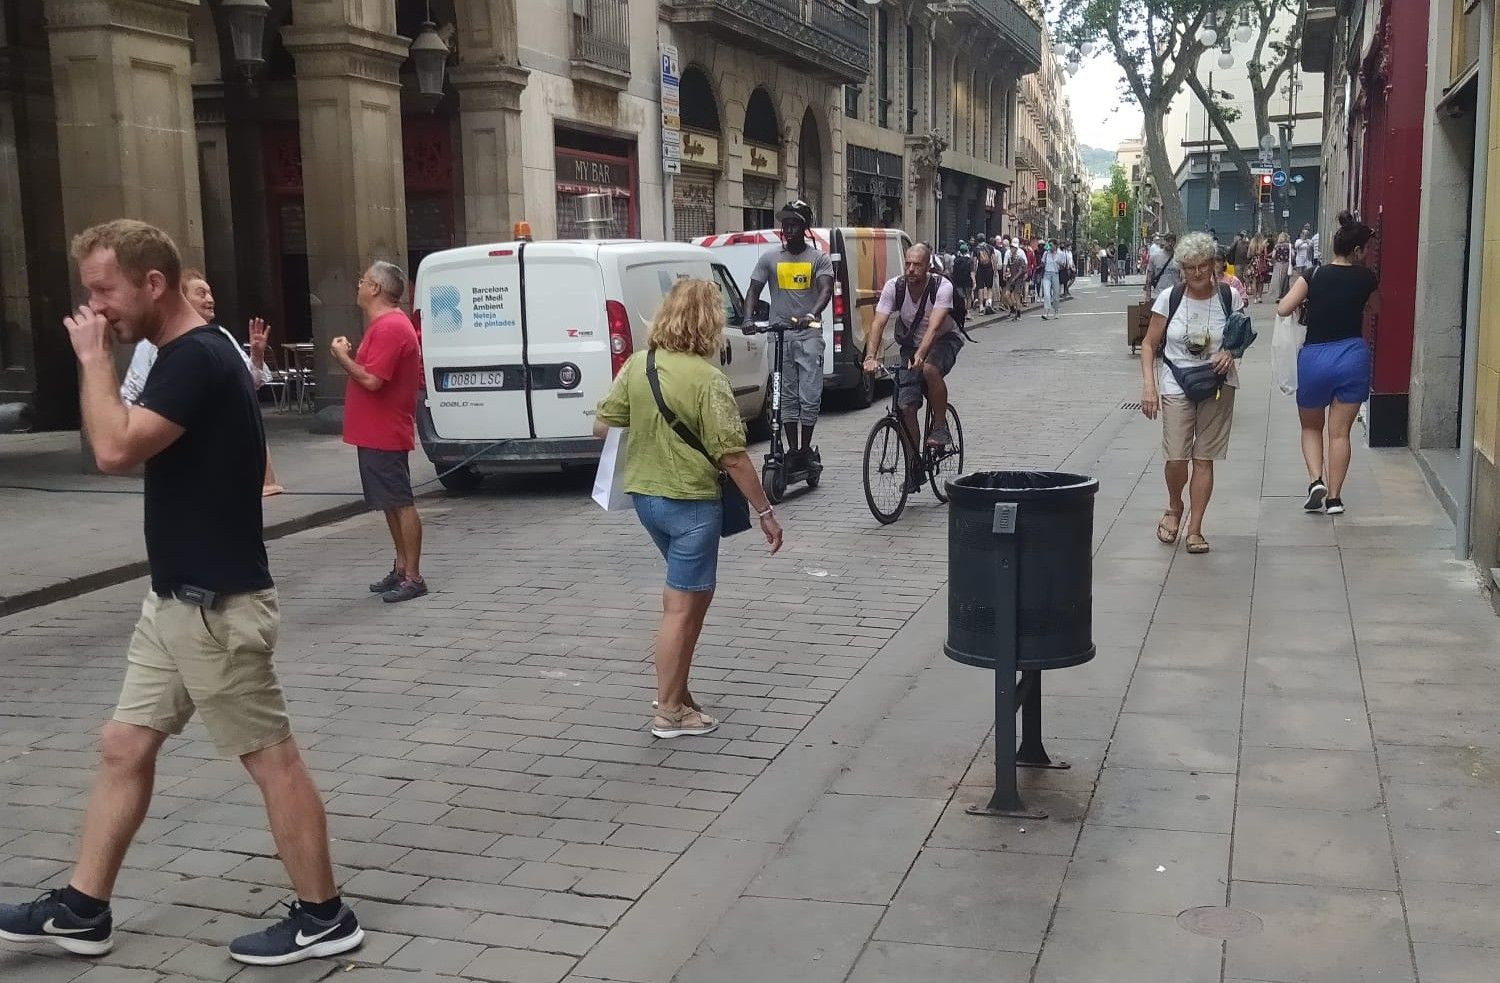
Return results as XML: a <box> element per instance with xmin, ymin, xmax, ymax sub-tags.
<box><xmin>282</xmin><ymin>15</ymin><xmax>408</xmax><ymax>431</ymax></box>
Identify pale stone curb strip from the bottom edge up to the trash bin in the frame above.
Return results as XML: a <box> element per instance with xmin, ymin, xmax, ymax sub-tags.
<box><xmin>573</xmin><ymin>585</ymin><xmax>948</xmax><ymax>983</ymax></box>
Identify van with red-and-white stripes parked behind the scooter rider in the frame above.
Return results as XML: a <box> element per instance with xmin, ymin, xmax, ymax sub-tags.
<box><xmin>693</xmin><ymin>228</ymin><xmax>912</xmax><ymax>407</ymax></box>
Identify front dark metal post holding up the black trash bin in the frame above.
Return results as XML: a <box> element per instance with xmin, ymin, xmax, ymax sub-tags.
<box><xmin>966</xmin><ymin>501</ymin><xmax>1047</xmax><ymax>819</ymax></box>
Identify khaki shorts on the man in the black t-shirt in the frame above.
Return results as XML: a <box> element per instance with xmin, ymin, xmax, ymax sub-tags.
<box><xmin>114</xmin><ymin>590</ymin><xmax>291</xmax><ymax>758</ymax></box>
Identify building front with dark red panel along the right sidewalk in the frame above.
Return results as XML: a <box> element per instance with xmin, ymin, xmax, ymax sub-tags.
<box><xmin>1302</xmin><ymin>0</ymin><xmax>1500</xmax><ymax>597</ymax></box>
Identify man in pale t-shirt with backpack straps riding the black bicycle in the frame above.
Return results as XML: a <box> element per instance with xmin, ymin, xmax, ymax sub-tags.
<box><xmin>864</xmin><ymin>243</ymin><xmax>963</xmax><ymax>491</ymax></box>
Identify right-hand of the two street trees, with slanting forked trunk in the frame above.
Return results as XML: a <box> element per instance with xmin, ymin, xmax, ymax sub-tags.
<box><xmin>1187</xmin><ymin>0</ymin><xmax>1302</xmax><ymax>228</ymax></box>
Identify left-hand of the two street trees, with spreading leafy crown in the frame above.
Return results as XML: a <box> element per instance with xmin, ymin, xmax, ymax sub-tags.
<box><xmin>1053</xmin><ymin>0</ymin><xmax>1233</xmax><ymax>231</ymax></box>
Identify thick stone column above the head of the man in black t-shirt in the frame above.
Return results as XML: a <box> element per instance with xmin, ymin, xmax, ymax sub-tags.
<box><xmin>47</xmin><ymin>0</ymin><xmax>203</xmax><ymax>266</ymax></box>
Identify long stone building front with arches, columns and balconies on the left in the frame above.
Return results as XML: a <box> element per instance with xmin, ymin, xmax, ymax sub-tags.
<box><xmin>0</xmin><ymin>0</ymin><xmax>1071</xmax><ymax>428</ymax></box>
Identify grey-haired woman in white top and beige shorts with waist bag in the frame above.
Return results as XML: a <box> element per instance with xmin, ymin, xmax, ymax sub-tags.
<box><xmin>1140</xmin><ymin>233</ymin><xmax>1244</xmax><ymax>555</ymax></box>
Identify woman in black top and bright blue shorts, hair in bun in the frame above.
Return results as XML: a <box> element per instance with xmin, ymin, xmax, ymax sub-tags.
<box><xmin>1277</xmin><ymin>212</ymin><xmax>1380</xmax><ymax>515</ymax></box>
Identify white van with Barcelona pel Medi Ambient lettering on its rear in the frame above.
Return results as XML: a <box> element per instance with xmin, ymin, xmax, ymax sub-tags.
<box><xmin>413</xmin><ymin>240</ymin><xmax>770</xmax><ymax>491</ymax></box>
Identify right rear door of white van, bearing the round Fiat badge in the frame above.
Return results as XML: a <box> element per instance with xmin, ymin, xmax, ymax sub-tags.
<box><xmin>524</xmin><ymin>242</ymin><xmax>615</xmax><ymax>437</ymax></box>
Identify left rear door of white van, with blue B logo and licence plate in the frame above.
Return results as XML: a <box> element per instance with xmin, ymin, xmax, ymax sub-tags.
<box><xmin>414</xmin><ymin>246</ymin><xmax>533</xmax><ymax>440</ymax></box>
